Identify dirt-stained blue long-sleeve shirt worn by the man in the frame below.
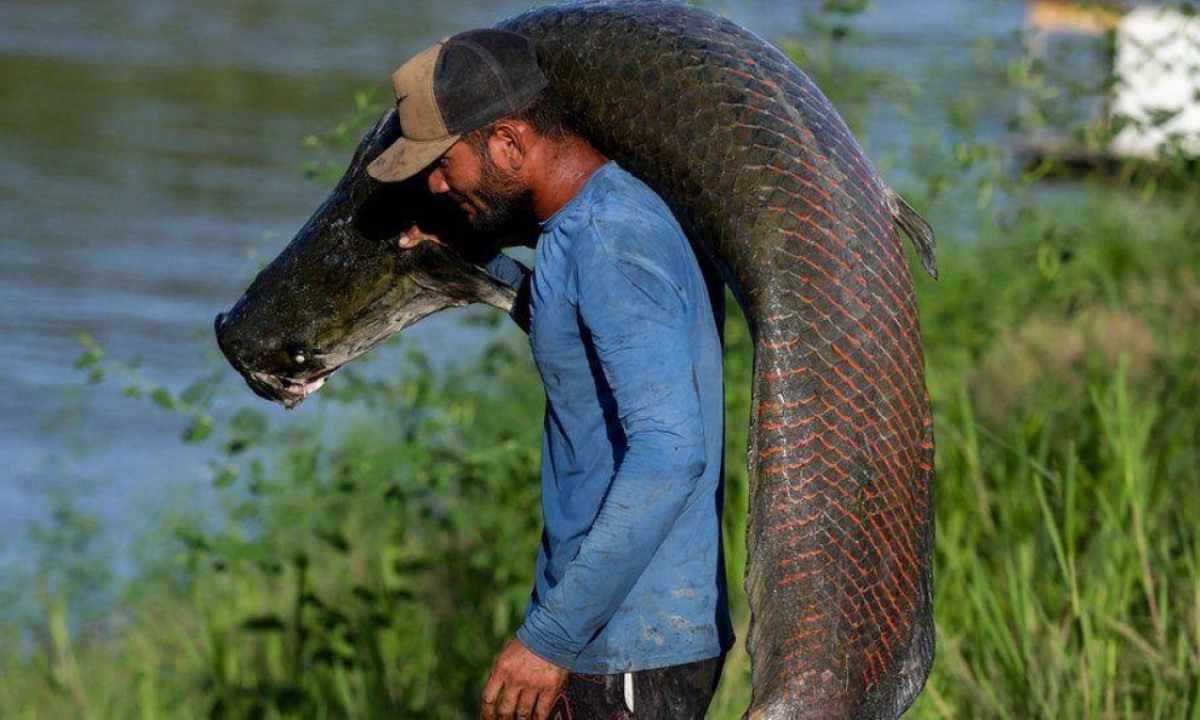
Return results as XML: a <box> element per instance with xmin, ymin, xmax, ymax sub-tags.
<box><xmin>493</xmin><ymin>163</ymin><xmax>733</xmax><ymax>673</ymax></box>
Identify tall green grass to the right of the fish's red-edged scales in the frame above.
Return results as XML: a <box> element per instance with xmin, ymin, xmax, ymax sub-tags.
<box><xmin>917</xmin><ymin>190</ymin><xmax>1200</xmax><ymax>718</ymax></box>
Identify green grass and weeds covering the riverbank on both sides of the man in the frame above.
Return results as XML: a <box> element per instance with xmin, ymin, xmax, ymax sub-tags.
<box><xmin>0</xmin><ymin>10</ymin><xmax>1200</xmax><ymax>719</ymax></box>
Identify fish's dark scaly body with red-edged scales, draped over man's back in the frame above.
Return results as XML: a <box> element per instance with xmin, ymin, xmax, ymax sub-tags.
<box><xmin>218</xmin><ymin>1</ymin><xmax>934</xmax><ymax>719</ymax></box>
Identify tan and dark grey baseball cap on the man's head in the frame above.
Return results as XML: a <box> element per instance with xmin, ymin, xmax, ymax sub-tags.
<box><xmin>367</xmin><ymin>30</ymin><xmax>548</xmax><ymax>182</ymax></box>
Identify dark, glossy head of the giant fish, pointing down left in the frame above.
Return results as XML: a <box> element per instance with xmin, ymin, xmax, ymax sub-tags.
<box><xmin>215</xmin><ymin>109</ymin><xmax>515</xmax><ymax>409</ymax></box>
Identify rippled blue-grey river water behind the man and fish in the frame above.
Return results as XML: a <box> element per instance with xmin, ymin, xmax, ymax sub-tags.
<box><xmin>0</xmin><ymin>0</ymin><xmax>1024</xmax><ymax>566</ymax></box>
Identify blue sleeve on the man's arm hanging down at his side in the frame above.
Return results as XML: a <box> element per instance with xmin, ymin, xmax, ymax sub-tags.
<box><xmin>517</xmin><ymin>240</ymin><xmax>706</xmax><ymax>667</ymax></box>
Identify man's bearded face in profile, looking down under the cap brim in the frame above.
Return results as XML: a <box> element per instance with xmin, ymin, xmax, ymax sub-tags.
<box><xmin>428</xmin><ymin>140</ymin><xmax>533</xmax><ymax>232</ymax></box>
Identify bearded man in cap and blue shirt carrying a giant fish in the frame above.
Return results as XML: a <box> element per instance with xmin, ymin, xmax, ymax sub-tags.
<box><xmin>370</xmin><ymin>30</ymin><xmax>732</xmax><ymax>720</ymax></box>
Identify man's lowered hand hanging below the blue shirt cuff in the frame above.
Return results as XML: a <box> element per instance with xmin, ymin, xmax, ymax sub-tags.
<box><xmin>480</xmin><ymin>638</ymin><xmax>569</xmax><ymax>720</ymax></box>
